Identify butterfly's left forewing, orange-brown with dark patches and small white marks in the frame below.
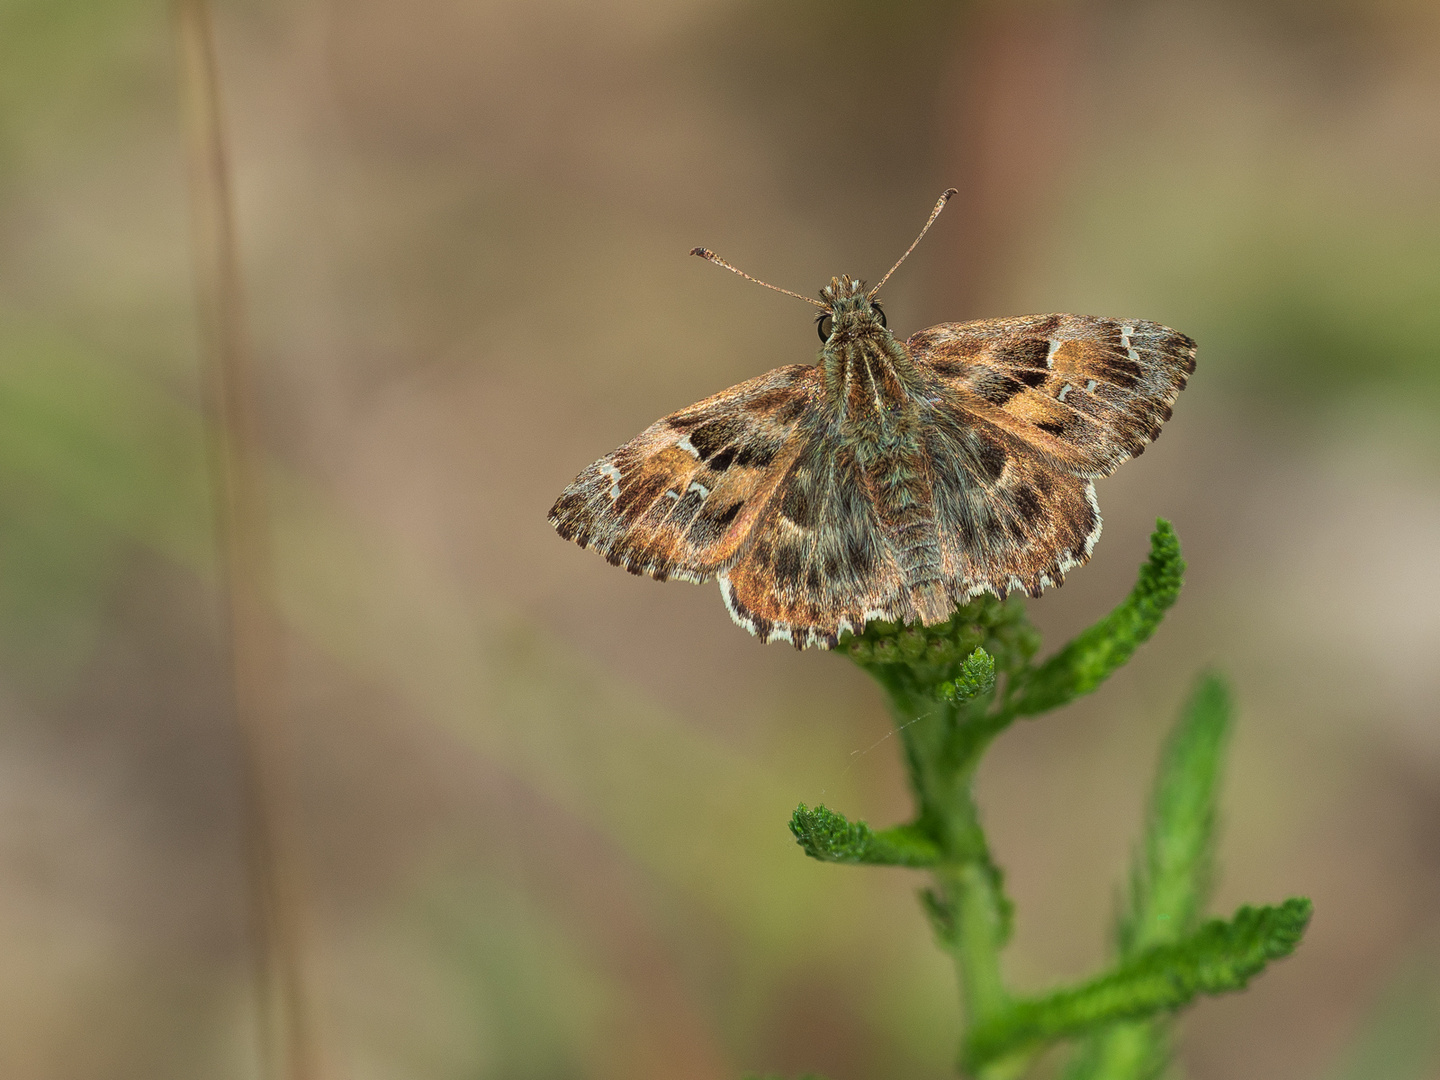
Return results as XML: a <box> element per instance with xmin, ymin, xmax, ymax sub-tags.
<box><xmin>550</xmin><ymin>364</ymin><xmax>821</xmax><ymax>582</ymax></box>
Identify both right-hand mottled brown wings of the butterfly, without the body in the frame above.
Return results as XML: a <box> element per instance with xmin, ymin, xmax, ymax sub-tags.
<box><xmin>907</xmin><ymin>315</ymin><xmax>1195</xmax><ymax>602</ymax></box>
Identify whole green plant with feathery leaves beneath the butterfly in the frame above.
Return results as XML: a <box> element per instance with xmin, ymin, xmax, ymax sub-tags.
<box><xmin>791</xmin><ymin>521</ymin><xmax>1310</xmax><ymax>1080</ymax></box>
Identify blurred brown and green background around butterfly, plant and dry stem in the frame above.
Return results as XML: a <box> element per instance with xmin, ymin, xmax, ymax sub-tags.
<box><xmin>0</xmin><ymin>0</ymin><xmax>1440</xmax><ymax>1080</ymax></box>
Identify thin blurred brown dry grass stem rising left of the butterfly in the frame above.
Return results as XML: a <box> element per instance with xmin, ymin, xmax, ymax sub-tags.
<box><xmin>176</xmin><ymin>0</ymin><xmax>320</xmax><ymax>1080</ymax></box>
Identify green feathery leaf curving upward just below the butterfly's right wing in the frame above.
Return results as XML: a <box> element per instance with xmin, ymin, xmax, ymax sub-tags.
<box><xmin>1009</xmin><ymin>518</ymin><xmax>1185</xmax><ymax>716</ymax></box>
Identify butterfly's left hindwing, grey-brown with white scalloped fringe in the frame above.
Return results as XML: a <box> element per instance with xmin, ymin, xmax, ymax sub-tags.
<box><xmin>719</xmin><ymin>434</ymin><xmax>916</xmax><ymax>648</ymax></box>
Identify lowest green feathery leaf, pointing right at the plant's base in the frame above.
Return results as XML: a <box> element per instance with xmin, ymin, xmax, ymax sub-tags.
<box><xmin>962</xmin><ymin>899</ymin><xmax>1310</xmax><ymax>1071</ymax></box>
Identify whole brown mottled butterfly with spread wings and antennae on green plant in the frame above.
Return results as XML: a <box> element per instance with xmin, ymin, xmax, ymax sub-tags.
<box><xmin>550</xmin><ymin>189</ymin><xmax>1195</xmax><ymax>648</ymax></box>
